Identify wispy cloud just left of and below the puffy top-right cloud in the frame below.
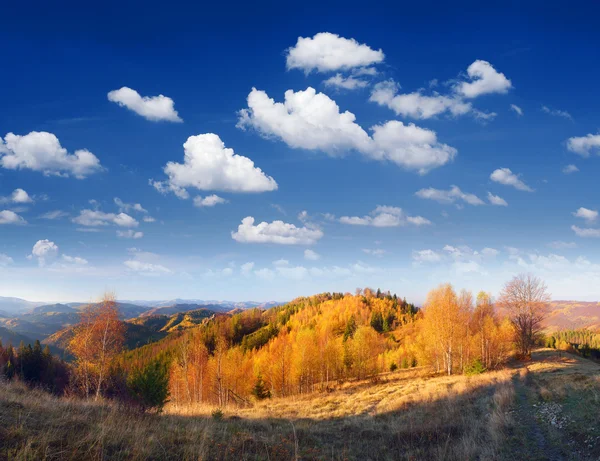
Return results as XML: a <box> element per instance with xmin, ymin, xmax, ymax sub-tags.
<box><xmin>369</xmin><ymin>80</ymin><xmax>473</xmax><ymax>119</ymax></box>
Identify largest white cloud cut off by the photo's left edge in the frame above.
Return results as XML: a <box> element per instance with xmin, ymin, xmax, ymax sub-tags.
<box><xmin>0</xmin><ymin>131</ymin><xmax>102</xmax><ymax>179</ymax></box>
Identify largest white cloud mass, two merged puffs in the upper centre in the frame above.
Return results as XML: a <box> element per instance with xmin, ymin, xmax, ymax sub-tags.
<box><xmin>237</xmin><ymin>87</ymin><xmax>456</xmax><ymax>173</ymax></box>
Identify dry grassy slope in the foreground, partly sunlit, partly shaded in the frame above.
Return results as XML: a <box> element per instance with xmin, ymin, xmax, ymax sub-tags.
<box><xmin>0</xmin><ymin>351</ymin><xmax>600</xmax><ymax>460</ymax></box>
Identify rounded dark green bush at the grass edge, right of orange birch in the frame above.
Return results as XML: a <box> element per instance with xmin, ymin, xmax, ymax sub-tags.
<box><xmin>127</xmin><ymin>360</ymin><xmax>169</xmax><ymax>413</ymax></box>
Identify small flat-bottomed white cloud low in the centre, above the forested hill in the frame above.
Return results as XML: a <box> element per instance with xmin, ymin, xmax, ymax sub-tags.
<box><xmin>231</xmin><ymin>216</ymin><xmax>323</xmax><ymax>245</ymax></box>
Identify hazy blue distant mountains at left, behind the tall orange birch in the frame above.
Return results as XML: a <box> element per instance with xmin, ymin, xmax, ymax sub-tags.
<box><xmin>0</xmin><ymin>297</ymin><xmax>283</xmax><ymax>347</ymax></box>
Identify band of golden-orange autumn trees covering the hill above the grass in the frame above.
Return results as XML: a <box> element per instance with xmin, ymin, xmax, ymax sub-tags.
<box><xmin>0</xmin><ymin>275</ymin><xmax>549</xmax><ymax>410</ymax></box>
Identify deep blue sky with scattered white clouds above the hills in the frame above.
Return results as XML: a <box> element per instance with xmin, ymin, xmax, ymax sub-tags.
<box><xmin>0</xmin><ymin>2</ymin><xmax>600</xmax><ymax>302</ymax></box>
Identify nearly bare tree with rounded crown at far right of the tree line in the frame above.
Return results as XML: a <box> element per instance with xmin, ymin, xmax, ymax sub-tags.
<box><xmin>498</xmin><ymin>274</ymin><xmax>550</xmax><ymax>357</ymax></box>
